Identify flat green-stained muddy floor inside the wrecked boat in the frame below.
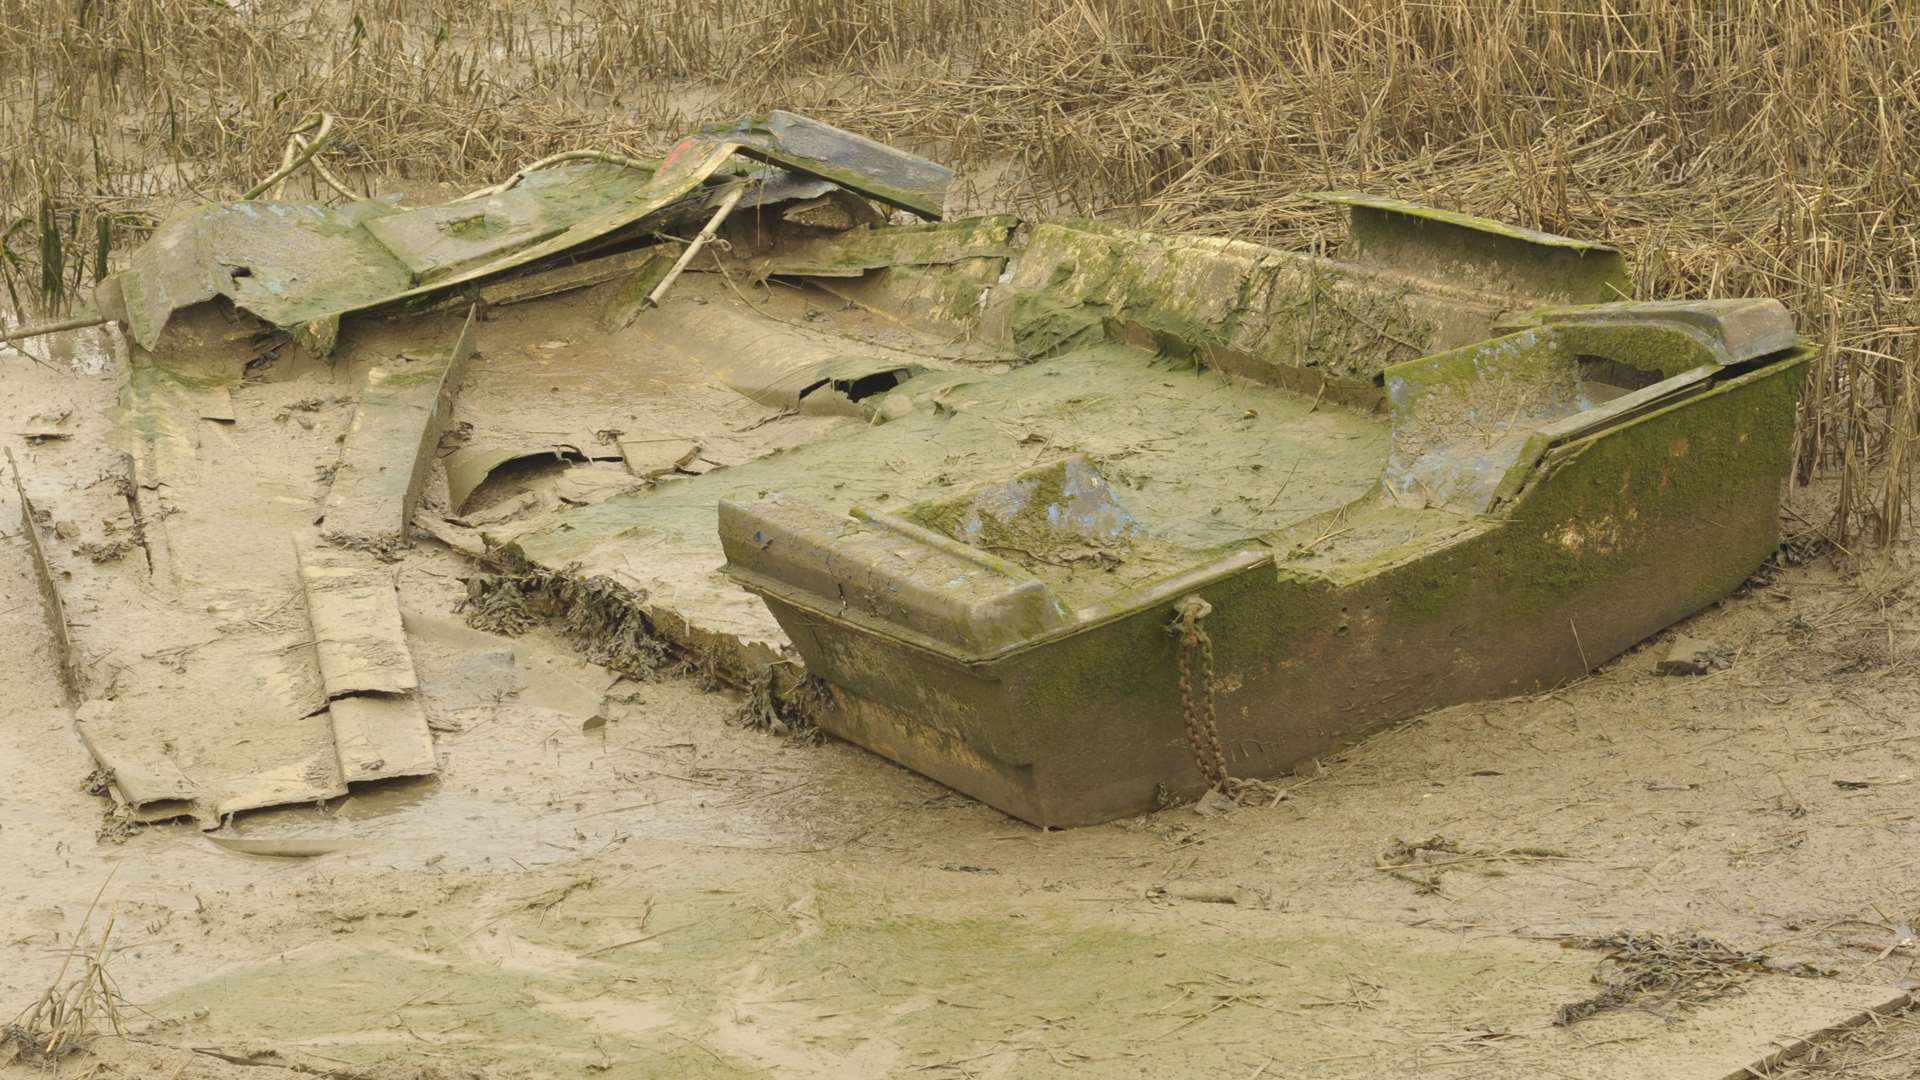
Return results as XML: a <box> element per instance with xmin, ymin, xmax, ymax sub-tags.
<box><xmin>515</xmin><ymin>346</ymin><xmax>1386</xmax><ymax>607</ymax></box>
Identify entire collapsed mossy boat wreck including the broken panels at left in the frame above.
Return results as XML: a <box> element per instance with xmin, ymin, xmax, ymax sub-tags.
<box><xmin>40</xmin><ymin>113</ymin><xmax>1807</xmax><ymax>826</ymax></box>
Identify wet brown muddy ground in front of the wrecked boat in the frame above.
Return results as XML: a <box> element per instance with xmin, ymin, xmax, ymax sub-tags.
<box><xmin>0</xmin><ymin>305</ymin><xmax>1920</xmax><ymax>1078</ymax></box>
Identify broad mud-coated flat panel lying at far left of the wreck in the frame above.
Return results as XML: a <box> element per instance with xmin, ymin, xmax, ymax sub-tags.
<box><xmin>56</xmin><ymin>306</ymin><xmax>346</xmax><ymax>824</ymax></box>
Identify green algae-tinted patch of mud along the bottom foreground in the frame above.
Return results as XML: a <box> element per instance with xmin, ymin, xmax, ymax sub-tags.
<box><xmin>148</xmin><ymin>878</ymin><xmax>1797</xmax><ymax>1078</ymax></box>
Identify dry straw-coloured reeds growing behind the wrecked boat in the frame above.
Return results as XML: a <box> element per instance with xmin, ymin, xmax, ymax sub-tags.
<box><xmin>0</xmin><ymin>0</ymin><xmax>1920</xmax><ymax>544</ymax></box>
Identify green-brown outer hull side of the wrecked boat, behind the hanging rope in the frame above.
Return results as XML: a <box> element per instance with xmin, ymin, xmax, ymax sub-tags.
<box><xmin>722</xmin><ymin>352</ymin><xmax>1809</xmax><ymax>826</ymax></box>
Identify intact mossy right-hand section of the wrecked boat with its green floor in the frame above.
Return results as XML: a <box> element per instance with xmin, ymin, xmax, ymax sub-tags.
<box><xmin>439</xmin><ymin>199</ymin><xmax>1803</xmax><ymax>824</ymax></box>
